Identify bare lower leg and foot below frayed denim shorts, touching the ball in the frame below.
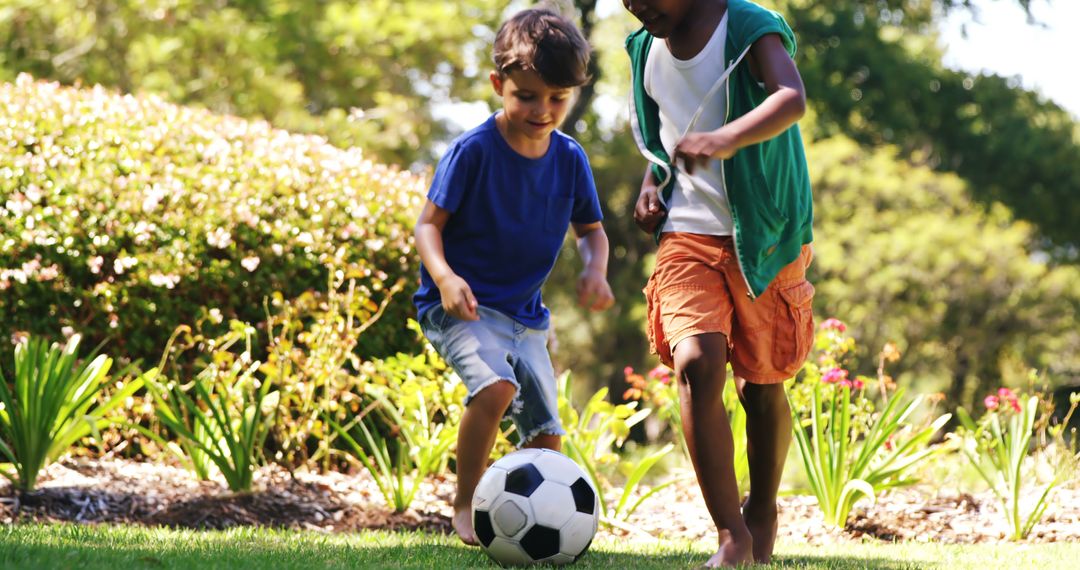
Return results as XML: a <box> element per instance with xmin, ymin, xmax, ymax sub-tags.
<box><xmin>454</xmin><ymin>381</ymin><xmax>517</xmax><ymax>545</ymax></box>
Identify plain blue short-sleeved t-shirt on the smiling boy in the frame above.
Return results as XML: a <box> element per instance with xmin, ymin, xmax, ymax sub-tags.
<box><xmin>413</xmin><ymin>114</ymin><xmax>603</xmax><ymax>328</ymax></box>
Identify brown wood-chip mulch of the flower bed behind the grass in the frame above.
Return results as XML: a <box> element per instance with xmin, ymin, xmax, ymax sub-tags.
<box><xmin>0</xmin><ymin>458</ymin><xmax>1080</xmax><ymax>544</ymax></box>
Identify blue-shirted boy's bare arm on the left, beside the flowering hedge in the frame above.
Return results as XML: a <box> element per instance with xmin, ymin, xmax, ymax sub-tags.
<box><xmin>413</xmin><ymin>200</ymin><xmax>480</xmax><ymax>321</ymax></box>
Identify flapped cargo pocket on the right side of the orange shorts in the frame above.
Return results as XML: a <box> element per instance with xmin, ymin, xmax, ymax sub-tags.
<box><xmin>772</xmin><ymin>280</ymin><xmax>813</xmax><ymax>375</ymax></box>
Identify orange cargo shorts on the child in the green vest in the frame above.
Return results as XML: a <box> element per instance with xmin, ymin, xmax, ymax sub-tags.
<box><xmin>645</xmin><ymin>232</ymin><xmax>813</xmax><ymax>384</ymax></box>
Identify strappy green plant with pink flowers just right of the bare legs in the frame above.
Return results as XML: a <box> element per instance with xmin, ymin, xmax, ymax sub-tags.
<box><xmin>788</xmin><ymin>318</ymin><xmax>950</xmax><ymax>527</ymax></box>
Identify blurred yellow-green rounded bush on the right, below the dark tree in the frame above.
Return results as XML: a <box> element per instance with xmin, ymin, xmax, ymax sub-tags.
<box><xmin>810</xmin><ymin>137</ymin><xmax>1080</xmax><ymax>408</ymax></box>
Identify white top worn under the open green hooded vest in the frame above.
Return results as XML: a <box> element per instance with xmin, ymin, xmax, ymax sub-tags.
<box><xmin>644</xmin><ymin>12</ymin><xmax>734</xmax><ymax>235</ymax></box>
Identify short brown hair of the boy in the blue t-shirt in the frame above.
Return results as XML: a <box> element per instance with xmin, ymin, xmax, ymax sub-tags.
<box><xmin>491</xmin><ymin>9</ymin><xmax>590</xmax><ymax>87</ymax></box>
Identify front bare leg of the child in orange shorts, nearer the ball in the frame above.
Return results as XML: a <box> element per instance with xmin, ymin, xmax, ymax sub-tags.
<box><xmin>673</xmin><ymin>333</ymin><xmax>753</xmax><ymax>568</ymax></box>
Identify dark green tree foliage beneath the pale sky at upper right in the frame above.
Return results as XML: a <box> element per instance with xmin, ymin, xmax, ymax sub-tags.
<box><xmin>777</xmin><ymin>0</ymin><xmax>1080</xmax><ymax>253</ymax></box>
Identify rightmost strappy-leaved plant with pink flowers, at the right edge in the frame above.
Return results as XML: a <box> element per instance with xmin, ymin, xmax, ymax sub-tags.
<box><xmin>953</xmin><ymin>375</ymin><xmax>1080</xmax><ymax>540</ymax></box>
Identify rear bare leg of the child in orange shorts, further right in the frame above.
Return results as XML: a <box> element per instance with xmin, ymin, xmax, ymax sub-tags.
<box><xmin>737</xmin><ymin>378</ymin><xmax>792</xmax><ymax>564</ymax></box>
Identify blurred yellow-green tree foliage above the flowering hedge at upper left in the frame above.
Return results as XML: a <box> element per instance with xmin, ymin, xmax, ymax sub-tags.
<box><xmin>0</xmin><ymin>0</ymin><xmax>509</xmax><ymax>166</ymax></box>
